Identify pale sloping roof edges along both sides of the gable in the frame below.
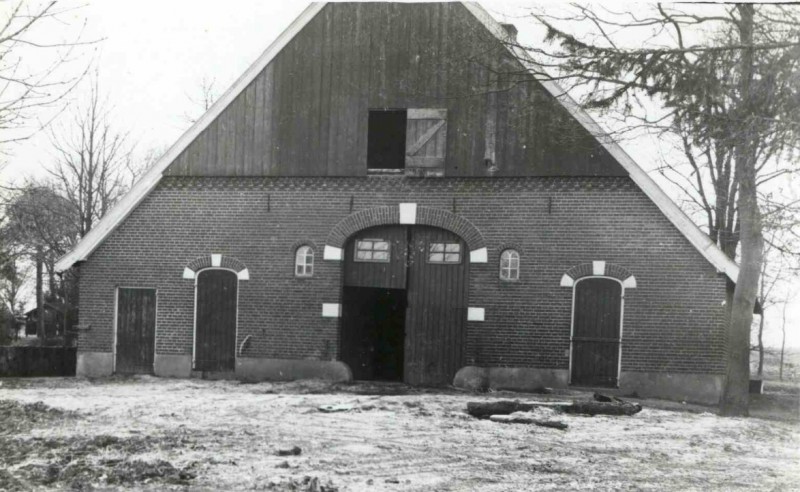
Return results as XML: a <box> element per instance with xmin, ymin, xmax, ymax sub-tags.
<box><xmin>56</xmin><ymin>2</ymin><xmax>739</xmax><ymax>281</ymax></box>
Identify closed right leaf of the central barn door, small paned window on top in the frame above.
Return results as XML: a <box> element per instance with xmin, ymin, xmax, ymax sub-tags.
<box><xmin>405</xmin><ymin>226</ymin><xmax>469</xmax><ymax>385</ymax></box>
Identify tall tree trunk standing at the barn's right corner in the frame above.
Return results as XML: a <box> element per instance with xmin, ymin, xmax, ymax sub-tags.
<box><xmin>720</xmin><ymin>4</ymin><xmax>764</xmax><ymax>416</ymax></box>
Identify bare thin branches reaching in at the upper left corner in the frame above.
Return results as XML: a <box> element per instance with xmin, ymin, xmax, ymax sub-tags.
<box><xmin>0</xmin><ymin>0</ymin><xmax>97</xmax><ymax>144</ymax></box>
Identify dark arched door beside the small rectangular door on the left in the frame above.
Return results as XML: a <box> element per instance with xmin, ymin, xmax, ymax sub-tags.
<box><xmin>194</xmin><ymin>270</ymin><xmax>238</xmax><ymax>372</ymax></box>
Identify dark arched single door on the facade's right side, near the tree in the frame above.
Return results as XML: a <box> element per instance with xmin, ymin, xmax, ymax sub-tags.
<box><xmin>571</xmin><ymin>278</ymin><xmax>622</xmax><ymax>387</ymax></box>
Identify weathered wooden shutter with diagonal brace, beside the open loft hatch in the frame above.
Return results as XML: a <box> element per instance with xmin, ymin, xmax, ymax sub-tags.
<box><xmin>406</xmin><ymin>109</ymin><xmax>447</xmax><ymax>177</ymax></box>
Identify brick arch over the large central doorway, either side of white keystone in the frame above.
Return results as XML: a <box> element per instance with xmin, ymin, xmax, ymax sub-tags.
<box><xmin>325</xmin><ymin>206</ymin><xmax>486</xmax><ymax>251</ymax></box>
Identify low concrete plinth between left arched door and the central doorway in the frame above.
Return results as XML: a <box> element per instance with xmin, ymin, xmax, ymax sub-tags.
<box><xmin>236</xmin><ymin>357</ymin><xmax>353</xmax><ymax>382</ymax></box>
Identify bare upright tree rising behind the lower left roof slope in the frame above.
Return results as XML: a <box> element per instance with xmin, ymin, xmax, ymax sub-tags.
<box><xmin>48</xmin><ymin>76</ymin><xmax>134</xmax><ymax>237</ymax></box>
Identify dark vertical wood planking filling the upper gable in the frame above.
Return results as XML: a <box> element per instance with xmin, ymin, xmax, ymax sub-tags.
<box><xmin>165</xmin><ymin>2</ymin><xmax>626</xmax><ymax>176</ymax></box>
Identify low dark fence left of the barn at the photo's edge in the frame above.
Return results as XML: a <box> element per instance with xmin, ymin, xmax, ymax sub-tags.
<box><xmin>0</xmin><ymin>347</ymin><xmax>77</xmax><ymax>377</ymax></box>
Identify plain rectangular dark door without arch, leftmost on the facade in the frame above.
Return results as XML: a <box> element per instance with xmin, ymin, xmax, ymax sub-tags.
<box><xmin>116</xmin><ymin>288</ymin><xmax>156</xmax><ymax>374</ymax></box>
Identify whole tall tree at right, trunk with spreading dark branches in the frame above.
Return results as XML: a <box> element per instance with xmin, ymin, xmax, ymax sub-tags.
<box><xmin>500</xmin><ymin>4</ymin><xmax>800</xmax><ymax>415</ymax></box>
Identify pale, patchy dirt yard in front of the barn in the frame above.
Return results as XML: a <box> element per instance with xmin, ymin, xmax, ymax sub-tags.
<box><xmin>0</xmin><ymin>377</ymin><xmax>800</xmax><ymax>491</ymax></box>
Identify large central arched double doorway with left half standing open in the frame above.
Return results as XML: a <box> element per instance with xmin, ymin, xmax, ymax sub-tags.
<box><xmin>340</xmin><ymin>225</ymin><xmax>469</xmax><ymax>385</ymax></box>
